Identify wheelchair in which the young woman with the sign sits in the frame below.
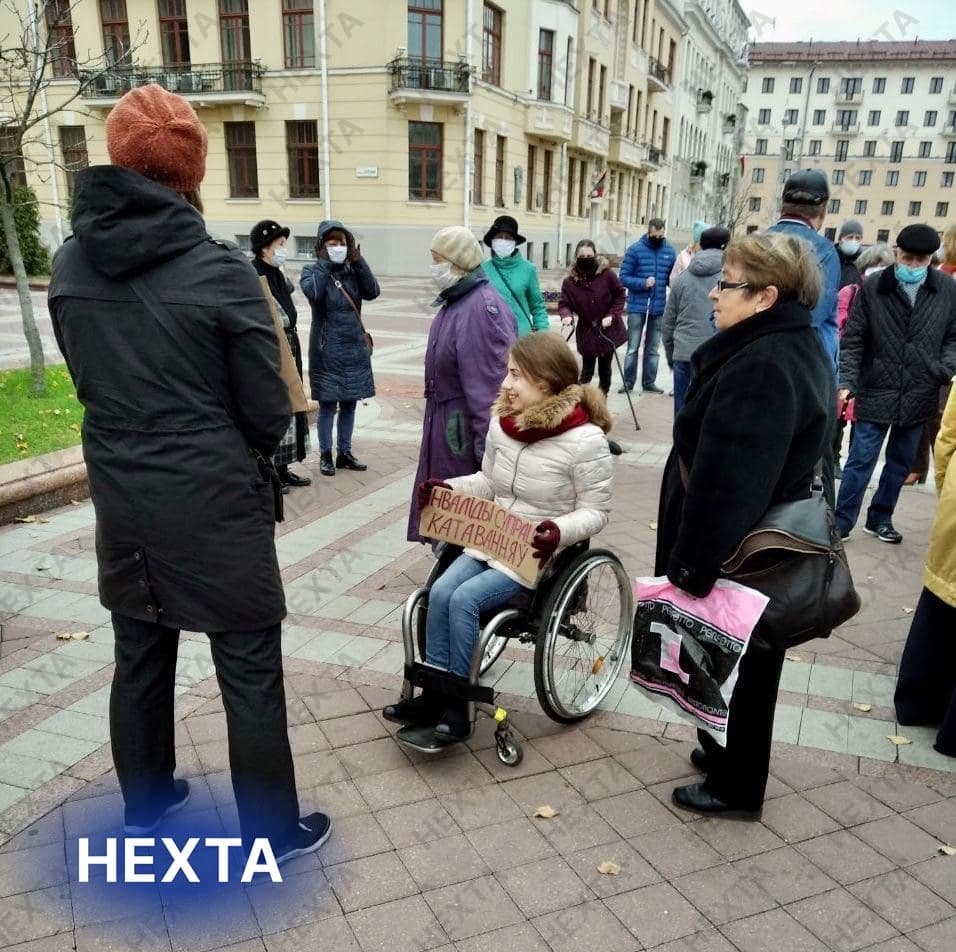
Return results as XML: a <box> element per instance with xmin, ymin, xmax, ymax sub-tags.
<box><xmin>396</xmin><ymin>541</ymin><xmax>634</xmax><ymax>767</ymax></box>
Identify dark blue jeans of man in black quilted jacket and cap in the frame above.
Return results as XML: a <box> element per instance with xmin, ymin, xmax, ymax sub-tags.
<box><xmin>836</xmin><ymin>420</ymin><xmax>923</xmax><ymax>534</ymax></box>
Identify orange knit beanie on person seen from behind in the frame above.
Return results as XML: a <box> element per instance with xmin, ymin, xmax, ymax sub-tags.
<box><xmin>106</xmin><ymin>83</ymin><xmax>208</xmax><ymax>192</ymax></box>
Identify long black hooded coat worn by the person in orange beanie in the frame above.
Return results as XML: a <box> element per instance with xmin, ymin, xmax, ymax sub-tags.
<box><xmin>50</xmin><ymin>166</ymin><xmax>291</xmax><ymax>631</ymax></box>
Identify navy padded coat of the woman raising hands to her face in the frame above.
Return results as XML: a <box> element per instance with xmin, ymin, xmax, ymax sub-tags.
<box><xmin>299</xmin><ymin>234</ymin><xmax>381</xmax><ymax>401</ymax></box>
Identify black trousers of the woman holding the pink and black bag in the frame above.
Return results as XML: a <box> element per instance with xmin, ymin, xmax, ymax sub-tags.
<box><xmin>697</xmin><ymin>628</ymin><xmax>784</xmax><ymax>810</ymax></box>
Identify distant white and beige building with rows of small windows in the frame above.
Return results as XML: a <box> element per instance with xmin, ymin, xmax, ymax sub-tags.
<box><xmin>739</xmin><ymin>40</ymin><xmax>956</xmax><ymax>242</ymax></box>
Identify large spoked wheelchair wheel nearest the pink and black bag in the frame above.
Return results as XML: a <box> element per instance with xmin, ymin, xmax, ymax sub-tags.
<box><xmin>534</xmin><ymin>549</ymin><xmax>634</xmax><ymax>724</ymax></box>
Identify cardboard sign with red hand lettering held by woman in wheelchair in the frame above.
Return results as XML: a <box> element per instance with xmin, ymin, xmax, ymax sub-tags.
<box><xmin>418</xmin><ymin>488</ymin><xmax>539</xmax><ymax>585</ymax></box>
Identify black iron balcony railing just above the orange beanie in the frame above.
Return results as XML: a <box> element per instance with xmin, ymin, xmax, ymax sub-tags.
<box><xmin>79</xmin><ymin>60</ymin><xmax>263</xmax><ymax>99</ymax></box>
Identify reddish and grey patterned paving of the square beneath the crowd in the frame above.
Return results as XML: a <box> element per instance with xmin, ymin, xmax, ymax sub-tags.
<box><xmin>0</xmin><ymin>282</ymin><xmax>956</xmax><ymax>952</ymax></box>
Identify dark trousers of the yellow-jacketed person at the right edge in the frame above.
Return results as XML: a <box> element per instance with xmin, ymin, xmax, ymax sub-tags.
<box><xmin>893</xmin><ymin>588</ymin><xmax>956</xmax><ymax>757</ymax></box>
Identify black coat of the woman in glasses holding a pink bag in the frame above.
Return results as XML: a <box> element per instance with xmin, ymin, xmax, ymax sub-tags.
<box><xmin>656</xmin><ymin>301</ymin><xmax>834</xmax><ymax>597</ymax></box>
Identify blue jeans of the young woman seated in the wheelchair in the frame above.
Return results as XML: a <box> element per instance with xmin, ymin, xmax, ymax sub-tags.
<box><xmin>425</xmin><ymin>555</ymin><xmax>524</xmax><ymax>678</ymax></box>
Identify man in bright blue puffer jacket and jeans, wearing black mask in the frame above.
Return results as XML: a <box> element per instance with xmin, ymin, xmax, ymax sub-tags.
<box><xmin>618</xmin><ymin>218</ymin><xmax>677</xmax><ymax>393</ymax></box>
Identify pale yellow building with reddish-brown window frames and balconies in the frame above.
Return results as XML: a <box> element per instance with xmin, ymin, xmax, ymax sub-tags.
<box><xmin>0</xmin><ymin>0</ymin><xmax>746</xmax><ymax>274</ymax></box>
